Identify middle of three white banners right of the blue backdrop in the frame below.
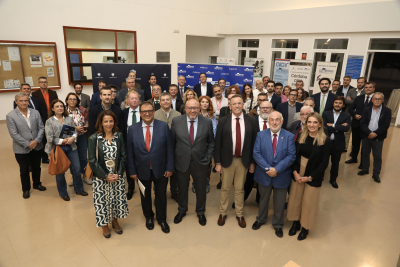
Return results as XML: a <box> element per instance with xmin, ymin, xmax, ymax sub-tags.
<box><xmin>288</xmin><ymin>59</ymin><xmax>312</xmax><ymax>91</ymax></box>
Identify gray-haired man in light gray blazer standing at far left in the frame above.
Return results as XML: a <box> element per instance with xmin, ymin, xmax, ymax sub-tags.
<box><xmin>6</xmin><ymin>92</ymin><xmax>46</xmax><ymax>198</ymax></box>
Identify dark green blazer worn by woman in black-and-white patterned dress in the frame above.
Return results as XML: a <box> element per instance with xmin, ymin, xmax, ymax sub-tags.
<box><xmin>88</xmin><ymin>133</ymin><xmax>126</xmax><ymax>180</ymax></box>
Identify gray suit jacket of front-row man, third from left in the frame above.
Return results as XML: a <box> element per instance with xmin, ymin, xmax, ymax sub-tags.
<box><xmin>171</xmin><ymin>115</ymin><xmax>214</xmax><ymax>172</ymax></box>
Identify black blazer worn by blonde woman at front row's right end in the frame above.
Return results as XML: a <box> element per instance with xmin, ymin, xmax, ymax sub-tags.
<box><xmin>290</xmin><ymin>137</ymin><xmax>331</xmax><ymax>187</ymax></box>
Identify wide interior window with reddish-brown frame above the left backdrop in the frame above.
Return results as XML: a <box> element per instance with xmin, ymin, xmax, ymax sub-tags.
<box><xmin>64</xmin><ymin>26</ymin><xmax>137</xmax><ymax>84</ymax></box>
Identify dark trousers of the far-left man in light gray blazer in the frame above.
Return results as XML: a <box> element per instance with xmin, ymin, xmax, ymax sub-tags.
<box><xmin>15</xmin><ymin>150</ymin><xmax>42</xmax><ymax>191</ymax></box>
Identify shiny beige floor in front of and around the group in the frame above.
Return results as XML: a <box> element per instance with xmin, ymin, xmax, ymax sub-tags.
<box><xmin>0</xmin><ymin>124</ymin><xmax>400</xmax><ymax>267</ymax></box>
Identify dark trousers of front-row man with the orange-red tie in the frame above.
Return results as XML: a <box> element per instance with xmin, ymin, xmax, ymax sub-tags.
<box><xmin>140</xmin><ymin>171</ymin><xmax>168</xmax><ymax>223</ymax></box>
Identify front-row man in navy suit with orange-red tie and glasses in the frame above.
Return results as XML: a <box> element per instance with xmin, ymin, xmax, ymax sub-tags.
<box><xmin>127</xmin><ymin>102</ymin><xmax>174</xmax><ymax>233</ymax></box>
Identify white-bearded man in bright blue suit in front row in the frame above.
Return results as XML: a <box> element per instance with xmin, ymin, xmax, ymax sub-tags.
<box><xmin>252</xmin><ymin>111</ymin><xmax>296</xmax><ymax>237</ymax></box>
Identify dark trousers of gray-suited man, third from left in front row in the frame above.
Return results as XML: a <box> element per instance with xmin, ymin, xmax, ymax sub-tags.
<box><xmin>176</xmin><ymin>161</ymin><xmax>208</xmax><ymax>215</ymax></box>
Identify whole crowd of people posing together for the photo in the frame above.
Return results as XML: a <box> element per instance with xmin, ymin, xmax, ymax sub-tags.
<box><xmin>7</xmin><ymin>71</ymin><xmax>391</xmax><ymax>243</ymax></box>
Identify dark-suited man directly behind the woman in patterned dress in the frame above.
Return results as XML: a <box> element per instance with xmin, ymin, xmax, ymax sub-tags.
<box><xmin>89</xmin><ymin>86</ymin><xmax>123</xmax><ymax>135</ymax></box>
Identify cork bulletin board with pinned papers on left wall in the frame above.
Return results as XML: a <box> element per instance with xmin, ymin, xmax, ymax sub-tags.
<box><xmin>0</xmin><ymin>40</ymin><xmax>61</xmax><ymax>93</ymax></box>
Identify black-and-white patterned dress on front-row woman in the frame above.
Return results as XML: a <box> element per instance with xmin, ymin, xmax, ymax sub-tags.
<box><xmin>93</xmin><ymin>134</ymin><xmax>129</xmax><ymax>227</ymax></box>
